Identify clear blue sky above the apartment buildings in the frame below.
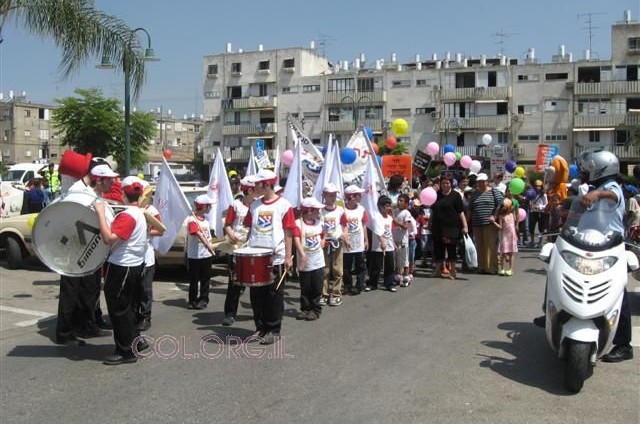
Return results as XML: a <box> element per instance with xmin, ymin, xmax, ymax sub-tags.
<box><xmin>0</xmin><ymin>0</ymin><xmax>640</xmax><ymax>117</ymax></box>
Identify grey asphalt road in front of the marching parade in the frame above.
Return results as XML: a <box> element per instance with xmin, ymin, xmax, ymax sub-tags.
<box><xmin>0</xmin><ymin>253</ymin><xmax>640</xmax><ymax>424</ymax></box>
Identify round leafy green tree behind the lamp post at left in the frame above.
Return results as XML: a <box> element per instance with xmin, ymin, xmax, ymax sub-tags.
<box><xmin>51</xmin><ymin>89</ymin><xmax>157</xmax><ymax>171</ymax></box>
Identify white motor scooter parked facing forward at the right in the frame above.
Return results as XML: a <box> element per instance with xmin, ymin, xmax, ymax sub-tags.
<box><xmin>539</xmin><ymin>198</ymin><xmax>639</xmax><ymax>393</ymax></box>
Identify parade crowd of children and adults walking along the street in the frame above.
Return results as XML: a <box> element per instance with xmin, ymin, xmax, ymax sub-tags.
<box><xmin>30</xmin><ymin>148</ymin><xmax>640</xmax><ymax>364</ymax></box>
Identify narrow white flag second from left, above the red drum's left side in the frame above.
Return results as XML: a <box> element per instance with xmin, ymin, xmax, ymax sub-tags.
<box><xmin>207</xmin><ymin>147</ymin><xmax>235</xmax><ymax>238</ymax></box>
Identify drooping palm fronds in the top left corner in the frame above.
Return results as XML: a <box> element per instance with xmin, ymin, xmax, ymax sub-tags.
<box><xmin>0</xmin><ymin>0</ymin><xmax>144</xmax><ymax>98</ymax></box>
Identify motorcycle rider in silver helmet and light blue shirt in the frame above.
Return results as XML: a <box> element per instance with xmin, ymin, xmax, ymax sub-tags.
<box><xmin>533</xmin><ymin>149</ymin><xmax>633</xmax><ymax>362</ymax></box>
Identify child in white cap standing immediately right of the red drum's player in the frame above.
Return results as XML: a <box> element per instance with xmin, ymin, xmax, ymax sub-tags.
<box><xmin>293</xmin><ymin>197</ymin><xmax>325</xmax><ymax>321</ymax></box>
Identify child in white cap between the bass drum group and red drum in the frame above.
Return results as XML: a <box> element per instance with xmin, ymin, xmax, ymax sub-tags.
<box><xmin>187</xmin><ymin>194</ymin><xmax>215</xmax><ymax>309</ymax></box>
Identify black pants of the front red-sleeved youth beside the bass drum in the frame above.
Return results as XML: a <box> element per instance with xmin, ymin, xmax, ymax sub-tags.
<box><xmin>104</xmin><ymin>263</ymin><xmax>144</xmax><ymax>356</ymax></box>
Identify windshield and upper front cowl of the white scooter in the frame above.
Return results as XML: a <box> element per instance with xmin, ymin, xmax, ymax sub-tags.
<box><xmin>560</xmin><ymin>196</ymin><xmax>623</xmax><ymax>251</ymax></box>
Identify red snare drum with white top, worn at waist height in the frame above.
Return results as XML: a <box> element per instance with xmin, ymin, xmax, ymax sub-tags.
<box><xmin>233</xmin><ymin>247</ymin><xmax>273</xmax><ymax>287</ymax></box>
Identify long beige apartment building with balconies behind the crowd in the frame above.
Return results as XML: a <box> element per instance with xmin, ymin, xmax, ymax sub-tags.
<box><xmin>203</xmin><ymin>11</ymin><xmax>640</xmax><ymax>171</ymax></box>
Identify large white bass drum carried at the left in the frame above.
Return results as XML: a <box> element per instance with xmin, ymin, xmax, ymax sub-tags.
<box><xmin>32</xmin><ymin>191</ymin><xmax>114</xmax><ymax>277</ymax></box>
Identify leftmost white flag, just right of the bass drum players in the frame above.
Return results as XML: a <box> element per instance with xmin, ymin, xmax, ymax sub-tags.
<box><xmin>151</xmin><ymin>157</ymin><xmax>192</xmax><ymax>255</ymax></box>
